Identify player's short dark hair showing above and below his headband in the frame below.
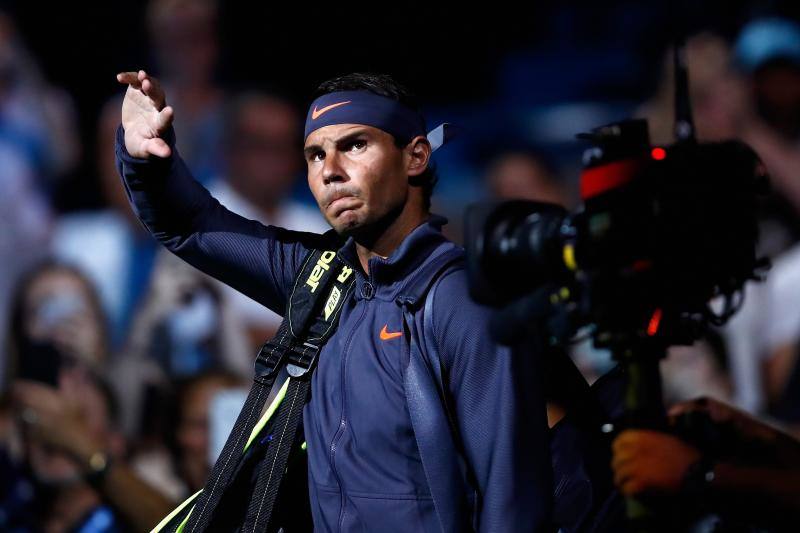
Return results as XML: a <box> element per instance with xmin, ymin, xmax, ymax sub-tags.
<box><xmin>314</xmin><ymin>72</ymin><xmax>439</xmax><ymax>210</ymax></box>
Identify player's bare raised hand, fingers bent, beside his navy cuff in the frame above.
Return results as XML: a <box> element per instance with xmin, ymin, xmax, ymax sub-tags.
<box><xmin>117</xmin><ymin>70</ymin><xmax>174</xmax><ymax>159</ymax></box>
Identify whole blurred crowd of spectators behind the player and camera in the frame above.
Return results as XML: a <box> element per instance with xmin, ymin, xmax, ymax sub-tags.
<box><xmin>0</xmin><ymin>0</ymin><xmax>800</xmax><ymax>532</ymax></box>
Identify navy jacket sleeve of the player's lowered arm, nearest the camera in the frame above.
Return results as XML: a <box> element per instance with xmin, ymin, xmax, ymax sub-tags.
<box><xmin>433</xmin><ymin>271</ymin><xmax>552</xmax><ymax>532</ymax></box>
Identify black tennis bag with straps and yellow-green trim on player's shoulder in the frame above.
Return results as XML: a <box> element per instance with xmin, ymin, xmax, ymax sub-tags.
<box><xmin>153</xmin><ymin>250</ymin><xmax>355</xmax><ymax>533</ymax></box>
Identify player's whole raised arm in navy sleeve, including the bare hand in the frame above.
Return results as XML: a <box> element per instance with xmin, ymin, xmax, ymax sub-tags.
<box><xmin>116</xmin><ymin>70</ymin><xmax>330</xmax><ymax>314</ymax></box>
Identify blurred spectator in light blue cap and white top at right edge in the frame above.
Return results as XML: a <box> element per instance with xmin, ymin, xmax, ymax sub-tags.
<box><xmin>725</xmin><ymin>18</ymin><xmax>800</xmax><ymax>418</ymax></box>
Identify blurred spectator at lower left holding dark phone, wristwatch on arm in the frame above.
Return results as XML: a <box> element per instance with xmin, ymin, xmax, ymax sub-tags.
<box><xmin>0</xmin><ymin>263</ymin><xmax>171</xmax><ymax>531</ymax></box>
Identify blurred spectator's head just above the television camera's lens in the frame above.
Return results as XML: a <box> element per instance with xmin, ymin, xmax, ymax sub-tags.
<box><xmin>487</xmin><ymin>154</ymin><xmax>569</xmax><ymax>207</ymax></box>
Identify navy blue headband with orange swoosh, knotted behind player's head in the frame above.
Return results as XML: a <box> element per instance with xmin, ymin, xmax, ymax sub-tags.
<box><xmin>303</xmin><ymin>91</ymin><xmax>452</xmax><ymax>150</ymax></box>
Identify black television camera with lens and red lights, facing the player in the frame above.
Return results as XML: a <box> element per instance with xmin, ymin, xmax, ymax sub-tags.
<box><xmin>466</xmin><ymin>120</ymin><xmax>767</xmax><ymax>347</ymax></box>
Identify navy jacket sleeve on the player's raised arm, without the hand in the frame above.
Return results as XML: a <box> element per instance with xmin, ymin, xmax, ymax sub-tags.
<box><xmin>116</xmin><ymin>126</ymin><xmax>330</xmax><ymax>315</ymax></box>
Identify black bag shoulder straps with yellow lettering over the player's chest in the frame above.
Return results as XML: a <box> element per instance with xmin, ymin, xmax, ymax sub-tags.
<box><xmin>173</xmin><ymin>248</ymin><xmax>355</xmax><ymax>533</ymax></box>
